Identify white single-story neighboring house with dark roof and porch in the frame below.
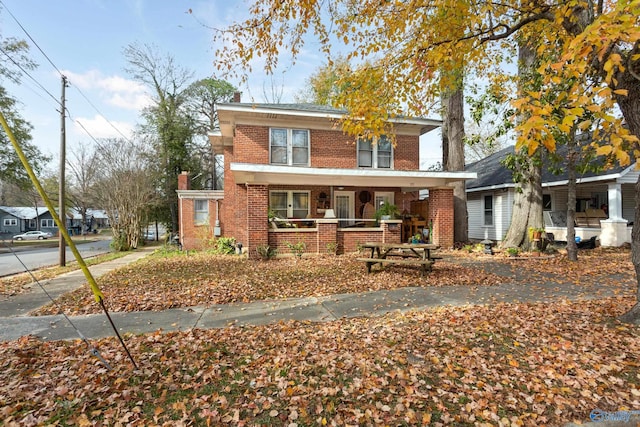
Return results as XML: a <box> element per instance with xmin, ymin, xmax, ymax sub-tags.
<box><xmin>465</xmin><ymin>146</ymin><xmax>638</xmax><ymax>246</ymax></box>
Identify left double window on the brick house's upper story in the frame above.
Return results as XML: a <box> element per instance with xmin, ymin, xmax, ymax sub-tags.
<box><xmin>269</xmin><ymin>128</ymin><xmax>309</xmax><ymax>166</ymax></box>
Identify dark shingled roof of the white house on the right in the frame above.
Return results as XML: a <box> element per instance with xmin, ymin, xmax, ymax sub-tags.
<box><xmin>465</xmin><ymin>146</ymin><xmax>634</xmax><ymax>191</ymax></box>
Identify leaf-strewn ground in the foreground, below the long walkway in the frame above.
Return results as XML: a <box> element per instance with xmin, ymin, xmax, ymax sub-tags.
<box><xmin>0</xmin><ymin>299</ymin><xmax>640</xmax><ymax>427</ymax></box>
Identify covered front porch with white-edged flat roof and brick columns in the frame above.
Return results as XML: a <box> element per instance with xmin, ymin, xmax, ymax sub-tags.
<box><xmin>230</xmin><ymin>163</ymin><xmax>475</xmax><ymax>257</ymax></box>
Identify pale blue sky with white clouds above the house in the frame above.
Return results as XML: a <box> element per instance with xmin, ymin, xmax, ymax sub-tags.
<box><xmin>0</xmin><ymin>0</ymin><xmax>440</xmax><ymax>170</ymax></box>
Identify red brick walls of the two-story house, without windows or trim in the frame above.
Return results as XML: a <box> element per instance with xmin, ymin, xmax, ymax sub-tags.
<box><xmin>178</xmin><ymin>104</ymin><xmax>462</xmax><ymax>258</ymax></box>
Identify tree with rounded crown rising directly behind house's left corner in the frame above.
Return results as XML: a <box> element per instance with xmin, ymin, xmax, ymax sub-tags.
<box><xmin>185</xmin><ymin>78</ymin><xmax>238</xmax><ymax>190</ymax></box>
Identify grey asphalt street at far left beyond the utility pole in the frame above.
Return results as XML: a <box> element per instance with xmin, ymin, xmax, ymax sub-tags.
<box><xmin>0</xmin><ymin>239</ymin><xmax>111</xmax><ymax>277</ymax></box>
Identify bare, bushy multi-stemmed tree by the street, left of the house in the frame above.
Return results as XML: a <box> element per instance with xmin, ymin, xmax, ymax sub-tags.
<box><xmin>95</xmin><ymin>139</ymin><xmax>157</xmax><ymax>251</ymax></box>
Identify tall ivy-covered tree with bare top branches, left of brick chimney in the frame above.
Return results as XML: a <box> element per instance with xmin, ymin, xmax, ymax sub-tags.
<box><xmin>124</xmin><ymin>44</ymin><xmax>200</xmax><ymax>232</ymax></box>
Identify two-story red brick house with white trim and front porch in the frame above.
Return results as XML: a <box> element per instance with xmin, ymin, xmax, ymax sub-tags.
<box><xmin>178</xmin><ymin>103</ymin><xmax>475</xmax><ymax>257</ymax></box>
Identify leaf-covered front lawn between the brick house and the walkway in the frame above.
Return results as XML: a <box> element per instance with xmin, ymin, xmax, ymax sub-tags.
<box><xmin>32</xmin><ymin>253</ymin><xmax>506</xmax><ymax>315</ymax></box>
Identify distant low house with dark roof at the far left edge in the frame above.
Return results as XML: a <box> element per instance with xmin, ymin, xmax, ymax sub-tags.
<box><xmin>0</xmin><ymin>206</ymin><xmax>58</xmax><ymax>235</ymax></box>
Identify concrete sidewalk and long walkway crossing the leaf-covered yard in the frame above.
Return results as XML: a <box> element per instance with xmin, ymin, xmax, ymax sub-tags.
<box><xmin>0</xmin><ymin>252</ymin><xmax>613</xmax><ymax>340</ymax></box>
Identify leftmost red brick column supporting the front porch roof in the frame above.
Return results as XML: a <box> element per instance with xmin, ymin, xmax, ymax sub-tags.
<box><xmin>240</xmin><ymin>185</ymin><xmax>269</xmax><ymax>259</ymax></box>
